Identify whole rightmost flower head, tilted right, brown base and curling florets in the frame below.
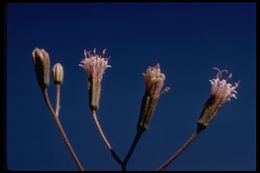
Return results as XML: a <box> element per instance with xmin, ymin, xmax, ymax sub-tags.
<box><xmin>198</xmin><ymin>67</ymin><xmax>240</xmax><ymax>129</ymax></box>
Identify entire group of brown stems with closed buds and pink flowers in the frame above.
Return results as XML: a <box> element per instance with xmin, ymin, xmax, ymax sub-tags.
<box><xmin>32</xmin><ymin>45</ymin><xmax>240</xmax><ymax>171</ymax></box>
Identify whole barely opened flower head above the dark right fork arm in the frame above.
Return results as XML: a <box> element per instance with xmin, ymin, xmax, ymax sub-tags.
<box><xmin>137</xmin><ymin>64</ymin><xmax>165</xmax><ymax>130</ymax></box>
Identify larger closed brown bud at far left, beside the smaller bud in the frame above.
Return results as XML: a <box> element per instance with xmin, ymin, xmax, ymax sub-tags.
<box><xmin>32</xmin><ymin>48</ymin><xmax>50</xmax><ymax>89</ymax></box>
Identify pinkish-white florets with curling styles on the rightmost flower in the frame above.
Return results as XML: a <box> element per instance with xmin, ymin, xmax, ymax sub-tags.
<box><xmin>209</xmin><ymin>67</ymin><xmax>240</xmax><ymax>104</ymax></box>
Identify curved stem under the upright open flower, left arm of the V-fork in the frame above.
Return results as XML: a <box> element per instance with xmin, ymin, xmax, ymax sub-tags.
<box><xmin>91</xmin><ymin>110</ymin><xmax>122</xmax><ymax>165</ymax></box>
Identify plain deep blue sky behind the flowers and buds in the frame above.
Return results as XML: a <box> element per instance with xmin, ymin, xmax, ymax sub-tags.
<box><xmin>7</xmin><ymin>3</ymin><xmax>256</xmax><ymax>170</ymax></box>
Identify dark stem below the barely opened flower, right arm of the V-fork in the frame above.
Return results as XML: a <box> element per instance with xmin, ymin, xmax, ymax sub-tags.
<box><xmin>121</xmin><ymin>129</ymin><xmax>144</xmax><ymax>171</ymax></box>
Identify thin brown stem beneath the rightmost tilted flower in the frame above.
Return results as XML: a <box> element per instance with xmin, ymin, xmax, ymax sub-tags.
<box><xmin>157</xmin><ymin>128</ymin><xmax>202</xmax><ymax>171</ymax></box>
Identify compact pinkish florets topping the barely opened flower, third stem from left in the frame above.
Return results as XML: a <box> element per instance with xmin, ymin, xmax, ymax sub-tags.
<box><xmin>143</xmin><ymin>64</ymin><xmax>165</xmax><ymax>95</ymax></box>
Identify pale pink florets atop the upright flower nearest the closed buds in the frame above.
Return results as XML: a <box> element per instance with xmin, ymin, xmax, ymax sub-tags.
<box><xmin>79</xmin><ymin>48</ymin><xmax>111</xmax><ymax>81</ymax></box>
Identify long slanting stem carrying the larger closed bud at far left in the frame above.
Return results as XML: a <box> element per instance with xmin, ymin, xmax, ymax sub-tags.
<box><xmin>42</xmin><ymin>88</ymin><xmax>84</xmax><ymax>171</ymax></box>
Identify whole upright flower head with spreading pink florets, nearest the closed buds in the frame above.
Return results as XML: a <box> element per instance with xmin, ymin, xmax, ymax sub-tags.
<box><xmin>79</xmin><ymin>49</ymin><xmax>111</xmax><ymax>110</ymax></box>
